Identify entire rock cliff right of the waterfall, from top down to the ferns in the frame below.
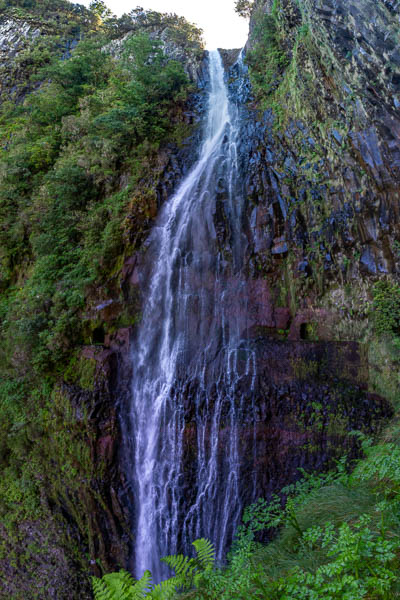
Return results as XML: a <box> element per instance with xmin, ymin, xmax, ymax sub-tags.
<box><xmin>203</xmin><ymin>0</ymin><xmax>400</xmax><ymax>516</ymax></box>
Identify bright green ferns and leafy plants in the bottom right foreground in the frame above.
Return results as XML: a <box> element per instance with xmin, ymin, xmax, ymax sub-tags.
<box><xmin>93</xmin><ymin>439</ymin><xmax>400</xmax><ymax>600</ymax></box>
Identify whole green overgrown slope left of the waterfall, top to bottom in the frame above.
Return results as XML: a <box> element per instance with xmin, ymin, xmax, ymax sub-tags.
<box><xmin>0</xmin><ymin>0</ymin><xmax>202</xmax><ymax>598</ymax></box>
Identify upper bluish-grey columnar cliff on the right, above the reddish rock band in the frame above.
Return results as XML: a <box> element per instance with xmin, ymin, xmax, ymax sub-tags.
<box><xmin>247</xmin><ymin>0</ymin><xmax>400</xmax><ymax>298</ymax></box>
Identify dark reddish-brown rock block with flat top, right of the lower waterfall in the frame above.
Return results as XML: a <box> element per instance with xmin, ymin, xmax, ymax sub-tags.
<box><xmin>182</xmin><ymin>338</ymin><xmax>392</xmax><ymax>514</ymax></box>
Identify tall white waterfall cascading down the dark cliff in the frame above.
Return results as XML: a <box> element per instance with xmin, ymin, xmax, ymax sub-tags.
<box><xmin>131</xmin><ymin>51</ymin><xmax>254</xmax><ymax>579</ymax></box>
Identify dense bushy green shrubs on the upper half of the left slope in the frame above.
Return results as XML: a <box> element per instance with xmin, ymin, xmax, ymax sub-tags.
<box><xmin>0</xmin><ymin>34</ymin><xmax>192</xmax><ymax>371</ymax></box>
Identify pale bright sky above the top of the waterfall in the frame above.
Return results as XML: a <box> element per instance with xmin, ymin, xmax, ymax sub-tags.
<box><xmin>81</xmin><ymin>0</ymin><xmax>249</xmax><ymax>50</ymax></box>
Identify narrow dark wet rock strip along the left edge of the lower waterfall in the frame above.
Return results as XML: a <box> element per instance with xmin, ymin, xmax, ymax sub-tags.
<box><xmin>62</xmin><ymin>340</ymin><xmax>134</xmax><ymax>575</ymax></box>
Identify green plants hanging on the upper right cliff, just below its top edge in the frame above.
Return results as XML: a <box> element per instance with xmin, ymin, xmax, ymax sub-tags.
<box><xmin>246</xmin><ymin>0</ymin><xmax>345</xmax><ymax>134</ymax></box>
